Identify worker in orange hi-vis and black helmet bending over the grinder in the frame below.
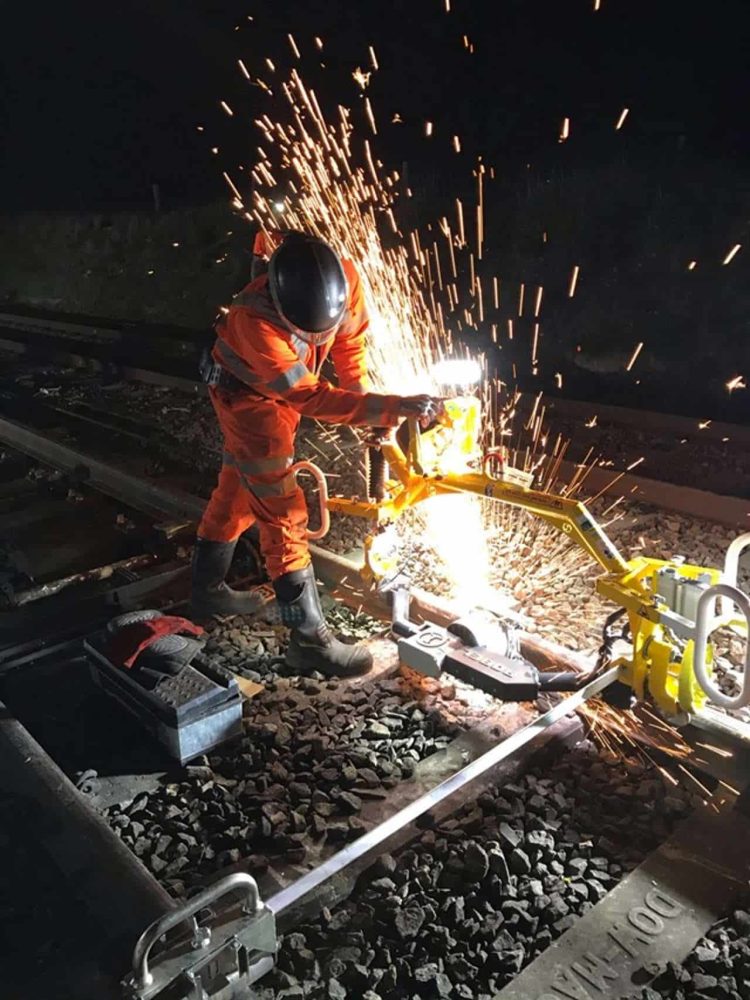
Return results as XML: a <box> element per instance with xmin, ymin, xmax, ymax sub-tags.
<box><xmin>192</xmin><ymin>232</ymin><xmax>442</xmax><ymax>676</ymax></box>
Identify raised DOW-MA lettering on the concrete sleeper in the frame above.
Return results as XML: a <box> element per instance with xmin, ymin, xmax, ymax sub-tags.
<box><xmin>536</xmin><ymin>889</ymin><xmax>684</xmax><ymax>1000</ymax></box>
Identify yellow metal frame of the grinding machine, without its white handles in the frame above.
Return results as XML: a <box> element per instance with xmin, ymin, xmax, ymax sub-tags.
<box><xmin>328</xmin><ymin>397</ymin><xmax>748</xmax><ymax>716</ymax></box>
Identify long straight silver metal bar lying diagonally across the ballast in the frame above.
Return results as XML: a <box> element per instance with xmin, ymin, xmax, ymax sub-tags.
<box><xmin>267</xmin><ymin>667</ymin><xmax>618</xmax><ymax>918</ymax></box>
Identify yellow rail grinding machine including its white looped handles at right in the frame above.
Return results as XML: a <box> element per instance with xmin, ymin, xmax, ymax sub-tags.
<box><xmin>327</xmin><ymin>396</ymin><xmax>750</xmax><ymax>716</ymax></box>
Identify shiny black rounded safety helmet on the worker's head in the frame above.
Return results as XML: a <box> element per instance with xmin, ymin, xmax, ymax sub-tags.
<box><xmin>268</xmin><ymin>232</ymin><xmax>349</xmax><ymax>344</ymax></box>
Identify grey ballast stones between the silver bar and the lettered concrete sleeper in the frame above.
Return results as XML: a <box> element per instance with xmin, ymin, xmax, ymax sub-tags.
<box><xmin>258</xmin><ymin>742</ymin><xmax>693</xmax><ymax>1000</ymax></box>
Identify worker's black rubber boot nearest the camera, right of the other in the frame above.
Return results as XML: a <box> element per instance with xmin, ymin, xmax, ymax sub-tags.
<box><xmin>273</xmin><ymin>566</ymin><xmax>372</xmax><ymax>677</ymax></box>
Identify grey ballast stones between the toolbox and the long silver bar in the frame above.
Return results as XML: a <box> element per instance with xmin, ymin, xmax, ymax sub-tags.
<box><xmin>107</xmin><ymin>678</ymin><xmax>470</xmax><ymax>896</ymax></box>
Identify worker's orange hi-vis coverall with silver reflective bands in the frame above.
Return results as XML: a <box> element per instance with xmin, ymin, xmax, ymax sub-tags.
<box><xmin>198</xmin><ymin>261</ymin><xmax>401</xmax><ymax>580</ymax></box>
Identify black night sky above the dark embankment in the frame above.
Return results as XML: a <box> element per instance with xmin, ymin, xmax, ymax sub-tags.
<box><xmin>0</xmin><ymin>0</ymin><xmax>750</xmax><ymax>211</ymax></box>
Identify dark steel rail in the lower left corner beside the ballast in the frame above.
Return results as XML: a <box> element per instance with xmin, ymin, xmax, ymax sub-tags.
<box><xmin>0</xmin><ymin>702</ymin><xmax>174</xmax><ymax>968</ymax></box>
